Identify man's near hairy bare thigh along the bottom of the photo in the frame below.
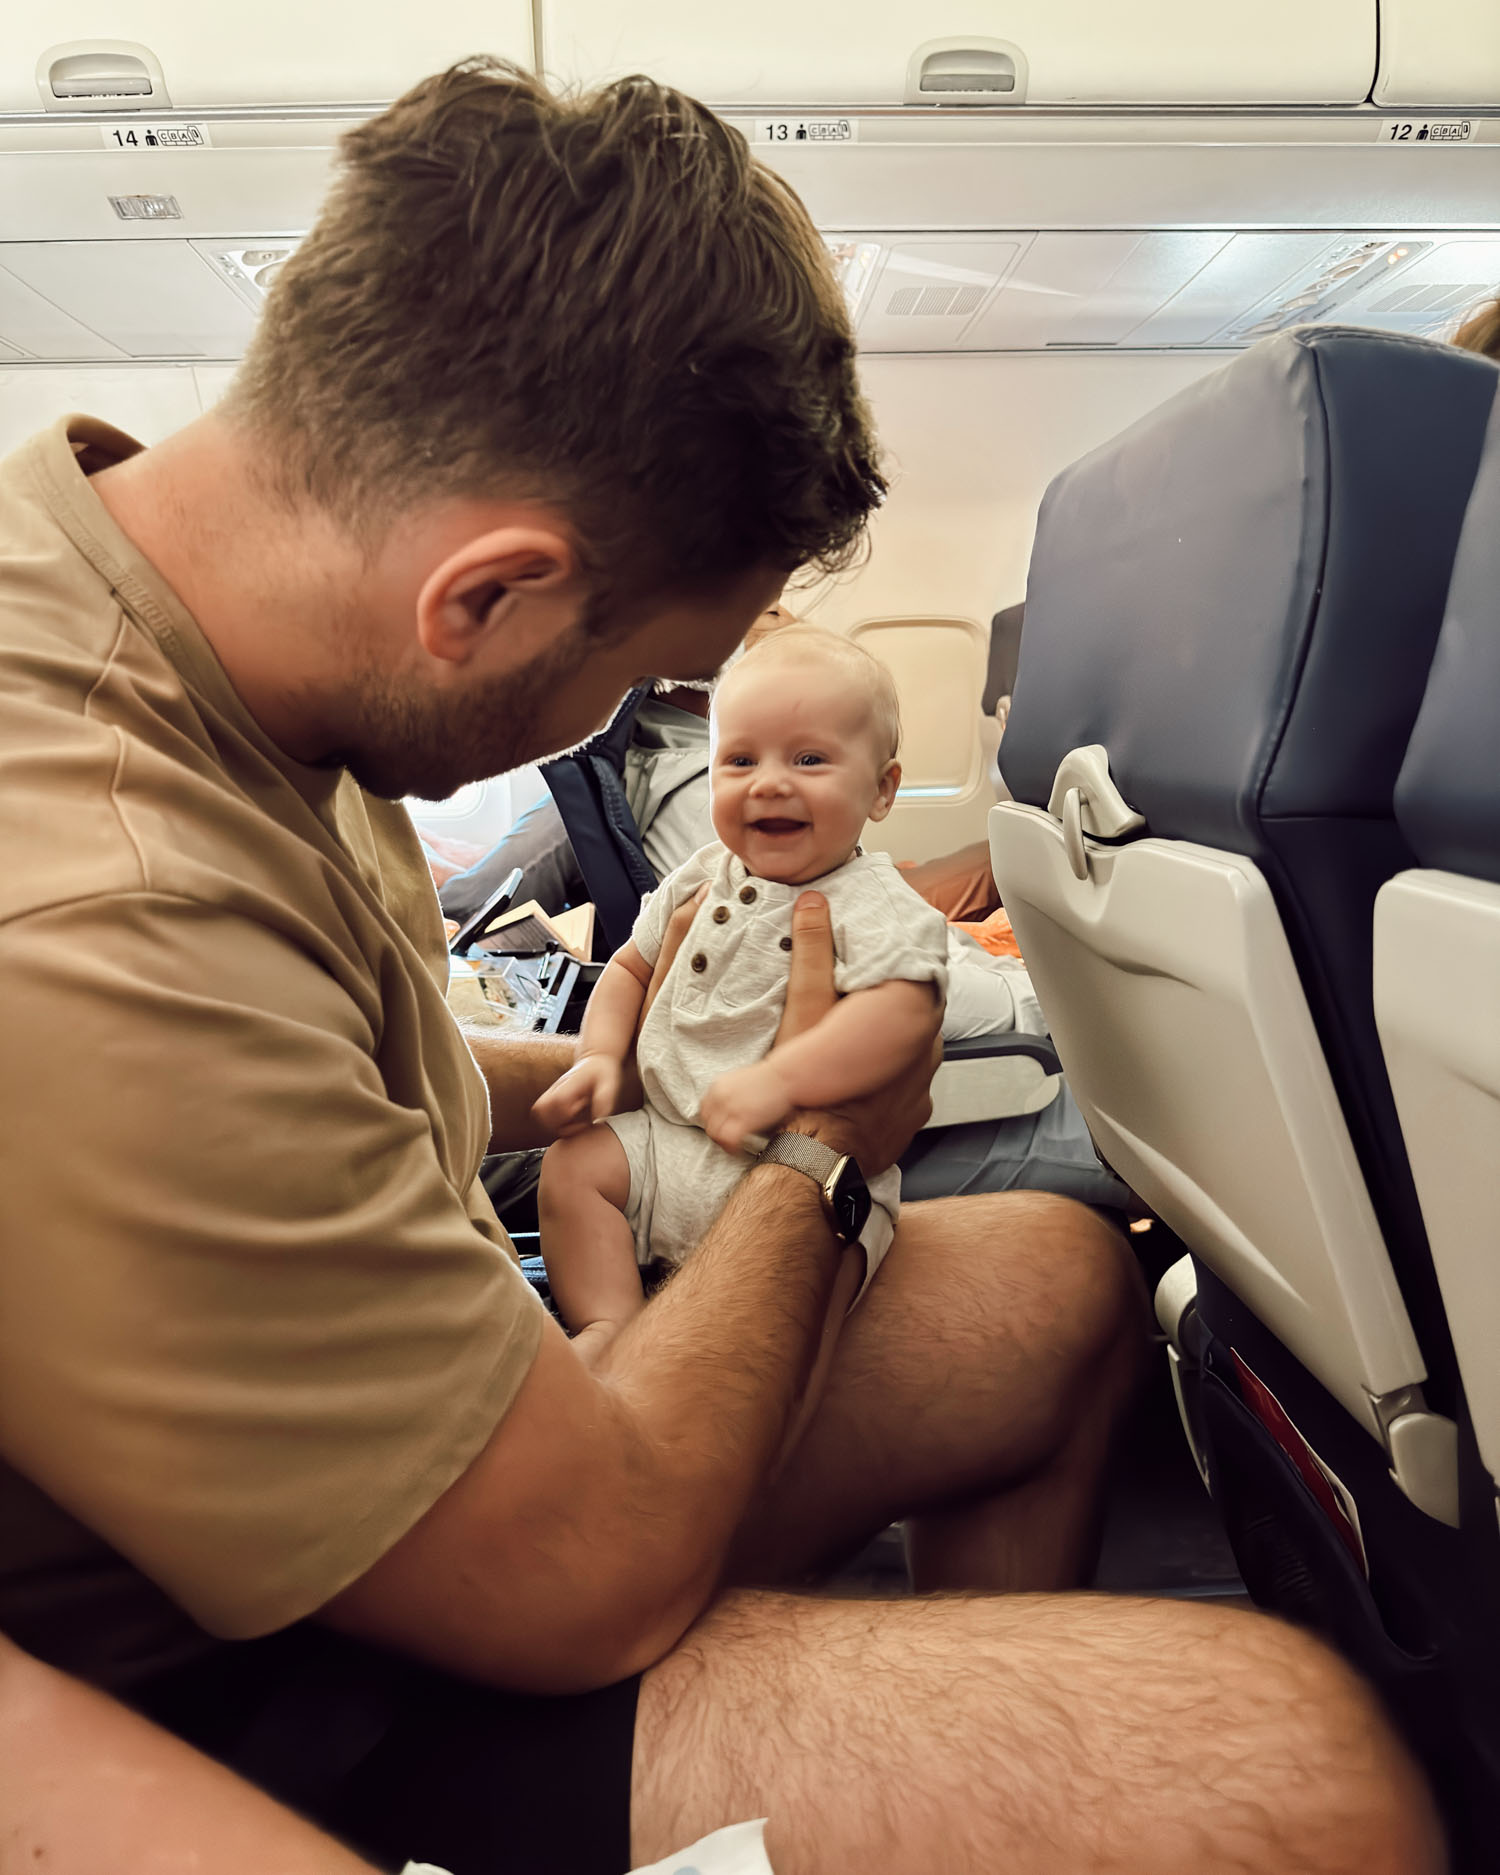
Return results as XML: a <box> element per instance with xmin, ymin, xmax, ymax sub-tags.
<box><xmin>630</xmin><ymin>1592</ymin><xmax>1444</xmax><ymax>1875</ymax></box>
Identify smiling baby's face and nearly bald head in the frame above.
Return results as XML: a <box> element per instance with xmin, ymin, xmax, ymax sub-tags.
<box><xmin>709</xmin><ymin>658</ymin><xmax>900</xmax><ymax>885</ymax></box>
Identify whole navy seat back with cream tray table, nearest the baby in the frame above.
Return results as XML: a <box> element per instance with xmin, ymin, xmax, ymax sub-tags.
<box><xmin>990</xmin><ymin>328</ymin><xmax>1496</xmax><ymax>1492</ymax></box>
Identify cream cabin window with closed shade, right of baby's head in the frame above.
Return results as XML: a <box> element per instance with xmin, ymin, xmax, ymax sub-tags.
<box><xmin>848</xmin><ymin>617</ymin><xmax>998</xmax><ymax>859</ymax></box>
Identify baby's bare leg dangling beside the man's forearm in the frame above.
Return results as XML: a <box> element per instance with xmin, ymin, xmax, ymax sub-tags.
<box><xmin>536</xmin><ymin>1125</ymin><xmax>645</xmax><ymax>1359</ymax></box>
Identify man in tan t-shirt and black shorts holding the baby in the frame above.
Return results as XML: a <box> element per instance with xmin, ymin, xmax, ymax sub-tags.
<box><xmin>0</xmin><ymin>64</ymin><xmax>1440</xmax><ymax>1875</ymax></box>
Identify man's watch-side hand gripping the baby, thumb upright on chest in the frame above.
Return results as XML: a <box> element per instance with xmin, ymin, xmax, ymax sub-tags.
<box><xmin>776</xmin><ymin>893</ymin><xmax>943</xmax><ymax>1178</ymax></box>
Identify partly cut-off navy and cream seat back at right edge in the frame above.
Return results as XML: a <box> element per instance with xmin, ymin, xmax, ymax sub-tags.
<box><xmin>1374</xmin><ymin>409</ymin><xmax>1500</xmax><ymax>1498</ymax></box>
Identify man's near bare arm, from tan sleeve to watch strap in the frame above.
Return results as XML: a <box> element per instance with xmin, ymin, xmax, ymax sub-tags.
<box><xmin>326</xmin><ymin>1166</ymin><xmax>844</xmax><ymax>1693</ymax></box>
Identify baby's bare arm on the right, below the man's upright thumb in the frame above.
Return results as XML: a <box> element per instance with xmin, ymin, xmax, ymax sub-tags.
<box><xmin>698</xmin><ymin>979</ymin><xmax>938</xmax><ymax>1153</ymax></box>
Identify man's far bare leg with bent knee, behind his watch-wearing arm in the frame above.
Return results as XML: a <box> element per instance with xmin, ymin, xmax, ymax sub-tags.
<box><xmin>733</xmin><ymin>1193</ymin><xmax>1148</xmax><ymax>1590</ymax></box>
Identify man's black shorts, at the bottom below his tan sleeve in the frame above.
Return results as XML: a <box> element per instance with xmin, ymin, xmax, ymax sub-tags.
<box><xmin>131</xmin><ymin>1624</ymin><xmax>639</xmax><ymax>1875</ymax></box>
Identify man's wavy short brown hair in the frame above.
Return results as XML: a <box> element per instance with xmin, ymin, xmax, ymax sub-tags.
<box><xmin>225</xmin><ymin>58</ymin><xmax>885</xmax><ymax>609</ymax></box>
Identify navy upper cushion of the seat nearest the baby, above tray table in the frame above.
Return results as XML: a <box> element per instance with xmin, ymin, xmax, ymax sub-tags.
<box><xmin>1001</xmin><ymin>326</ymin><xmax>1500</xmax><ymax>859</ymax></box>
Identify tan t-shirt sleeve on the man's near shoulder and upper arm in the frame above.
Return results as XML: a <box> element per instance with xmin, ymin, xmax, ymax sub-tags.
<box><xmin>0</xmin><ymin>891</ymin><xmax>542</xmax><ymax>1637</ymax></box>
